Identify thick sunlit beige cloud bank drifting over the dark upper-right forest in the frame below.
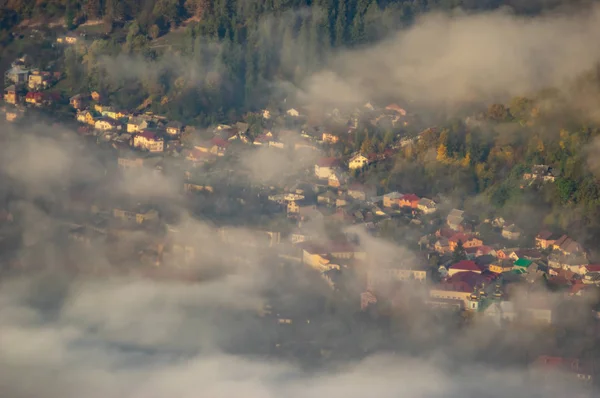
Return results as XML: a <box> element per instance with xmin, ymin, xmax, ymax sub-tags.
<box><xmin>304</xmin><ymin>7</ymin><xmax>600</xmax><ymax>110</ymax></box>
